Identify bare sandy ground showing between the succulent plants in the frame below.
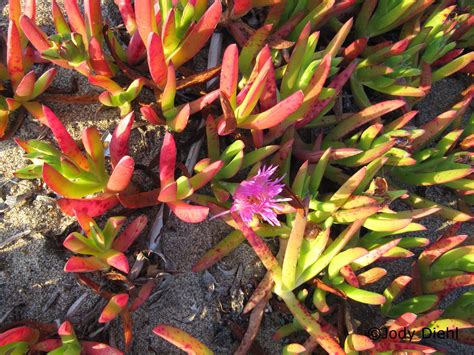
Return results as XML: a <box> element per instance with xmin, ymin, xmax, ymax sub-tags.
<box><xmin>0</xmin><ymin>1</ymin><xmax>474</xmax><ymax>354</ymax></box>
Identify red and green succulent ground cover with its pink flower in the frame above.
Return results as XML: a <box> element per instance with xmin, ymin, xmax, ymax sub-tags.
<box><xmin>0</xmin><ymin>0</ymin><xmax>474</xmax><ymax>354</ymax></box>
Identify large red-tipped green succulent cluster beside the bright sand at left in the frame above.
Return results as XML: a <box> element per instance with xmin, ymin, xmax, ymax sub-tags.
<box><xmin>15</xmin><ymin>106</ymin><xmax>134</xmax><ymax>216</ymax></box>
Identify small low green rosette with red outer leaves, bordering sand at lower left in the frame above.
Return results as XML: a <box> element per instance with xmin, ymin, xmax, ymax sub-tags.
<box><xmin>63</xmin><ymin>215</ymin><xmax>147</xmax><ymax>273</ymax></box>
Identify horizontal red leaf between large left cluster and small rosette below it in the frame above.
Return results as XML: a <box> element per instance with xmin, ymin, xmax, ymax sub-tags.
<box><xmin>57</xmin><ymin>195</ymin><xmax>119</xmax><ymax>217</ymax></box>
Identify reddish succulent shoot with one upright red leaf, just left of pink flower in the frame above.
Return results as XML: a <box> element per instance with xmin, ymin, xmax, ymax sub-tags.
<box><xmin>119</xmin><ymin>132</ymin><xmax>223</xmax><ymax>223</ymax></box>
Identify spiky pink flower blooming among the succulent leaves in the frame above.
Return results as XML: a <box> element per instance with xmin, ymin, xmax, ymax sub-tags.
<box><xmin>230</xmin><ymin>166</ymin><xmax>289</xmax><ymax>226</ymax></box>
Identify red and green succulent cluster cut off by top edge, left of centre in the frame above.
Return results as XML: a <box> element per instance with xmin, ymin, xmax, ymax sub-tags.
<box><xmin>116</xmin><ymin>0</ymin><xmax>222</xmax><ymax>69</ymax></box>
